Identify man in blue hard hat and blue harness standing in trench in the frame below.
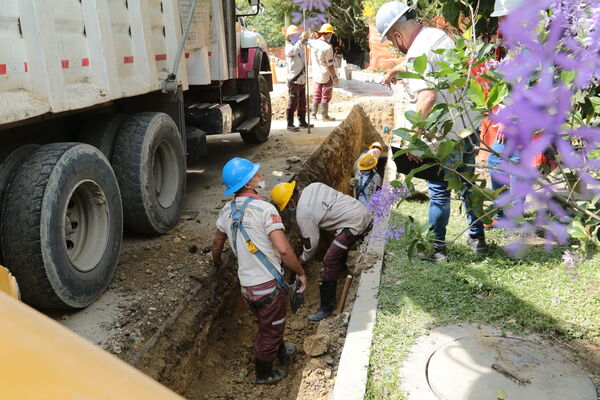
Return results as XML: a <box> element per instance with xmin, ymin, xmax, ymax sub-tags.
<box><xmin>212</xmin><ymin>157</ymin><xmax>306</xmax><ymax>384</ymax></box>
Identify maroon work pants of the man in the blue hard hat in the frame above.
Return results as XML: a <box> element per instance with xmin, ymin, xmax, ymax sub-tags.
<box><xmin>242</xmin><ymin>280</ymin><xmax>288</xmax><ymax>362</ymax></box>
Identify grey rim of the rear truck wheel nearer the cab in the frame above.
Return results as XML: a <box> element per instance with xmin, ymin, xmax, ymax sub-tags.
<box><xmin>152</xmin><ymin>141</ymin><xmax>179</xmax><ymax>208</ymax></box>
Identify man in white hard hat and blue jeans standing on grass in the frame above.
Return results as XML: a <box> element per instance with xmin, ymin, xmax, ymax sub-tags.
<box><xmin>375</xmin><ymin>1</ymin><xmax>487</xmax><ymax>263</ymax></box>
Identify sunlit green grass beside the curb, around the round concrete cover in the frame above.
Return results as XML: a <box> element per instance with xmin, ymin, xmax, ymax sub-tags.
<box><xmin>365</xmin><ymin>202</ymin><xmax>600</xmax><ymax>400</ymax></box>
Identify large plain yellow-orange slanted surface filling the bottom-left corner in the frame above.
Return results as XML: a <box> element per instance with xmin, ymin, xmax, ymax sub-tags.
<box><xmin>0</xmin><ymin>292</ymin><xmax>183</xmax><ymax>400</ymax></box>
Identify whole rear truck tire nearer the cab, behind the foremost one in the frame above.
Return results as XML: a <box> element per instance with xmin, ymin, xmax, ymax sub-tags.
<box><xmin>112</xmin><ymin>112</ymin><xmax>185</xmax><ymax>234</ymax></box>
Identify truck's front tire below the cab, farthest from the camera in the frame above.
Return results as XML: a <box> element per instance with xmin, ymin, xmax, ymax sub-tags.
<box><xmin>241</xmin><ymin>76</ymin><xmax>273</xmax><ymax>144</ymax></box>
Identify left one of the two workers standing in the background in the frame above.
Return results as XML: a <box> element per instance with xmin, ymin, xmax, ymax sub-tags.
<box><xmin>285</xmin><ymin>25</ymin><xmax>308</xmax><ymax>132</ymax></box>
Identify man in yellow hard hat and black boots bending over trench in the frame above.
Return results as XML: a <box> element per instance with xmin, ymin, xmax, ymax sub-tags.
<box><xmin>271</xmin><ymin>181</ymin><xmax>371</xmax><ymax>322</ymax></box>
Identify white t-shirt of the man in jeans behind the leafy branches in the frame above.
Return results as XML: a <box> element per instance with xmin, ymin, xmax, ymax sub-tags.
<box><xmin>391</xmin><ymin>27</ymin><xmax>475</xmax><ymax>150</ymax></box>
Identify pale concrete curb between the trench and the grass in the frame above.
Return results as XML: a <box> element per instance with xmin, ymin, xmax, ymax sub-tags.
<box><xmin>332</xmin><ymin>148</ymin><xmax>396</xmax><ymax>400</ymax></box>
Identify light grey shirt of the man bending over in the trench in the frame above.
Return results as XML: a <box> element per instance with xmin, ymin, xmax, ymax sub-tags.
<box><xmin>296</xmin><ymin>182</ymin><xmax>371</xmax><ymax>261</ymax></box>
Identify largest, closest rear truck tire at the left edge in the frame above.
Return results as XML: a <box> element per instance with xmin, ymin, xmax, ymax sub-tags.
<box><xmin>0</xmin><ymin>143</ymin><xmax>123</xmax><ymax>309</ymax></box>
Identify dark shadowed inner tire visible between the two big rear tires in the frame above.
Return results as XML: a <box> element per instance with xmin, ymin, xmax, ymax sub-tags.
<box><xmin>77</xmin><ymin>113</ymin><xmax>127</xmax><ymax>160</ymax></box>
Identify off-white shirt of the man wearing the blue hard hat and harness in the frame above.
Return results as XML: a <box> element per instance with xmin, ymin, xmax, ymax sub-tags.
<box><xmin>217</xmin><ymin>196</ymin><xmax>285</xmax><ymax>286</ymax></box>
